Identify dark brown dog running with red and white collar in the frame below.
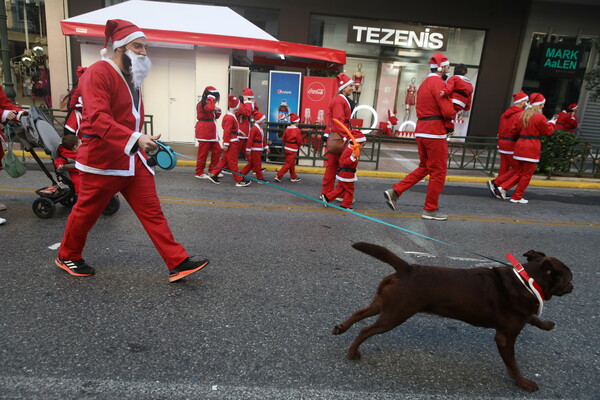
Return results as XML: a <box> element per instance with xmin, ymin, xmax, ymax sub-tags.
<box><xmin>333</xmin><ymin>242</ymin><xmax>573</xmax><ymax>392</ymax></box>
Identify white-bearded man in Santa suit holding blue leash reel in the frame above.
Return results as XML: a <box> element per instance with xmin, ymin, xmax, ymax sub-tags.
<box><xmin>55</xmin><ymin>19</ymin><xmax>208</xmax><ymax>282</ymax></box>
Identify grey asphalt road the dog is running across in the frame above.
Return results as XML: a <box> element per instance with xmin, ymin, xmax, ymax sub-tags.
<box><xmin>0</xmin><ymin>167</ymin><xmax>600</xmax><ymax>399</ymax></box>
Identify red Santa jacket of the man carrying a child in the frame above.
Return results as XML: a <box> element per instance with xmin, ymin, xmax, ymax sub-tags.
<box><xmin>415</xmin><ymin>73</ymin><xmax>456</xmax><ymax>139</ymax></box>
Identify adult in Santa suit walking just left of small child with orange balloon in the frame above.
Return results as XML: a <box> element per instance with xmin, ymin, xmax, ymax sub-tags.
<box><xmin>321</xmin><ymin>74</ymin><xmax>355</xmax><ymax>194</ymax></box>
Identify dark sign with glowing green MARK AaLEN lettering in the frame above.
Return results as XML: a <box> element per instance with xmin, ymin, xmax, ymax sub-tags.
<box><xmin>540</xmin><ymin>43</ymin><xmax>586</xmax><ymax>77</ymax></box>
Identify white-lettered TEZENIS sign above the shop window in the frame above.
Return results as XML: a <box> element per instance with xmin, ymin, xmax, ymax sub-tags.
<box><xmin>348</xmin><ymin>21</ymin><xmax>448</xmax><ymax>51</ymax></box>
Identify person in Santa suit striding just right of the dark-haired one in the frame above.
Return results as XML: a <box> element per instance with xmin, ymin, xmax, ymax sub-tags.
<box><xmin>208</xmin><ymin>95</ymin><xmax>250</xmax><ymax>187</ymax></box>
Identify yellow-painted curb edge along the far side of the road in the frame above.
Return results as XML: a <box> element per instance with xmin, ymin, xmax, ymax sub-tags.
<box><xmin>15</xmin><ymin>150</ymin><xmax>600</xmax><ymax>189</ymax></box>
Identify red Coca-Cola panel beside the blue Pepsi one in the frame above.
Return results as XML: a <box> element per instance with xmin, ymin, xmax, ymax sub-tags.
<box><xmin>299</xmin><ymin>76</ymin><xmax>337</xmax><ymax>125</ymax></box>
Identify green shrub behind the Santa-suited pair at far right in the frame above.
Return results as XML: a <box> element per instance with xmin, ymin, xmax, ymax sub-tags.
<box><xmin>538</xmin><ymin>130</ymin><xmax>579</xmax><ymax>176</ymax></box>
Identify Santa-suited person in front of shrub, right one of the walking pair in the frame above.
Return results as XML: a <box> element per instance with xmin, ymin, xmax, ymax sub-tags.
<box><xmin>497</xmin><ymin>93</ymin><xmax>556</xmax><ymax>204</ymax></box>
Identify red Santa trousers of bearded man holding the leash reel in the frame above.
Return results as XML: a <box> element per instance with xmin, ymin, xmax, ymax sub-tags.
<box><xmin>58</xmin><ymin>156</ymin><xmax>188</xmax><ymax>270</ymax></box>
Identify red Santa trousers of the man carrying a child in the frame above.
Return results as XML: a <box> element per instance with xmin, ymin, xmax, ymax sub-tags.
<box><xmin>392</xmin><ymin>137</ymin><xmax>448</xmax><ymax>211</ymax></box>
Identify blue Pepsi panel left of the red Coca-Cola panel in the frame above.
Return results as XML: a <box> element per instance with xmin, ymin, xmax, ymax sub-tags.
<box><xmin>267</xmin><ymin>71</ymin><xmax>302</xmax><ymax>145</ymax></box>
